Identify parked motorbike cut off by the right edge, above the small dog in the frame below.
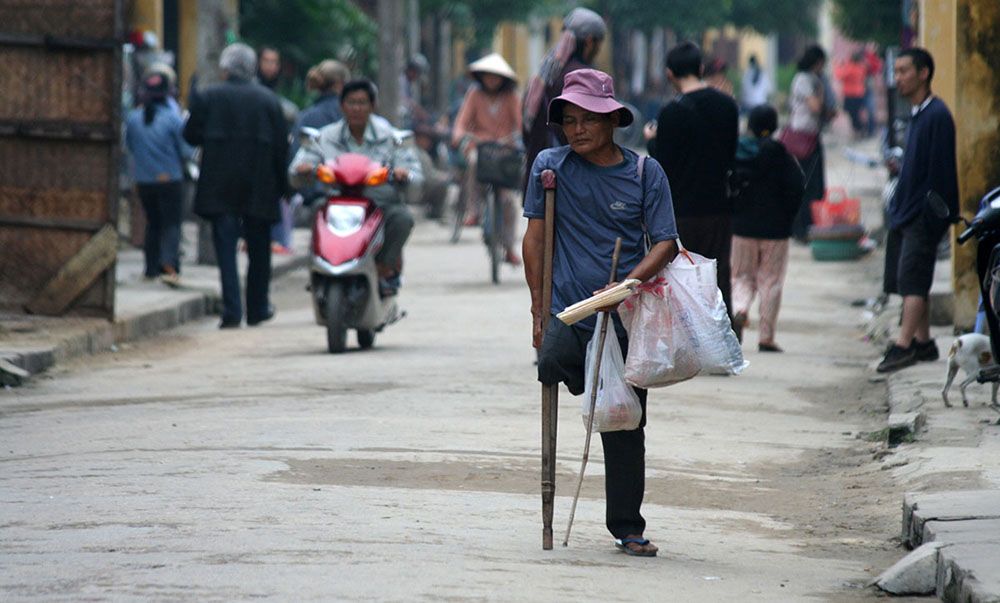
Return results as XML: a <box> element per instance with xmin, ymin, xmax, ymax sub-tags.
<box><xmin>928</xmin><ymin>187</ymin><xmax>1000</xmax><ymax>383</ymax></box>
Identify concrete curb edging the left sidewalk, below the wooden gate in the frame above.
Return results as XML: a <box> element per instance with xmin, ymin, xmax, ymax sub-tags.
<box><xmin>0</xmin><ymin>256</ymin><xmax>309</xmax><ymax>376</ymax></box>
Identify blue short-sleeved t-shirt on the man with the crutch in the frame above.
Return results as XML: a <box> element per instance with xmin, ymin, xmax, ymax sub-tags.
<box><xmin>524</xmin><ymin>145</ymin><xmax>677</xmax><ymax>329</ymax></box>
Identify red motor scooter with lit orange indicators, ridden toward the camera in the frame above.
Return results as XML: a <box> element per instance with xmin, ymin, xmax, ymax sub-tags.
<box><xmin>303</xmin><ymin>128</ymin><xmax>406</xmax><ymax>354</ymax></box>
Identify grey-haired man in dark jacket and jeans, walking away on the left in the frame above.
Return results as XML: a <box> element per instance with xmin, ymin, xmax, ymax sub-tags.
<box><xmin>184</xmin><ymin>43</ymin><xmax>288</xmax><ymax>329</ymax></box>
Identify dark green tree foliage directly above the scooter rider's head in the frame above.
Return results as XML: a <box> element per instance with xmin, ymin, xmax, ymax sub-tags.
<box><xmin>240</xmin><ymin>0</ymin><xmax>378</xmax><ymax>77</ymax></box>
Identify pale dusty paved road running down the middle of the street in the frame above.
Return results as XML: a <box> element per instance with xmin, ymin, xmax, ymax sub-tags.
<box><xmin>0</xmin><ymin>211</ymin><xmax>924</xmax><ymax>601</ymax></box>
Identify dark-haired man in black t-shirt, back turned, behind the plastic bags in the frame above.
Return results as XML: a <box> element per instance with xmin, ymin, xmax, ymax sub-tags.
<box><xmin>646</xmin><ymin>42</ymin><xmax>739</xmax><ymax>317</ymax></box>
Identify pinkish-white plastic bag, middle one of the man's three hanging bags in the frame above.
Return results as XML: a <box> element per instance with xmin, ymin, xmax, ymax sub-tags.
<box><xmin>618</xmin><ymin>278</ymin><xmax>701</xmax><ymax>388</ymax></box>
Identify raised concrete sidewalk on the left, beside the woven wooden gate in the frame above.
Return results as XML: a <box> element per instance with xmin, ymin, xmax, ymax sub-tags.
<box><xmin>0</xmin><ymin>223</ymin><xmax>309</xmax><ymax>382</ymax></box>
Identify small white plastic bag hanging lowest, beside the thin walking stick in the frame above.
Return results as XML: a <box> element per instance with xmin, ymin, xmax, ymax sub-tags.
<box><xmin>582</xmin><ymin>313</ymin><xmax>642</xmax><ymax>432</ymax></box>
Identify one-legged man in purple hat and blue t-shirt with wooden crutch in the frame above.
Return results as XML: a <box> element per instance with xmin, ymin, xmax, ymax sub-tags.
<box><xmin>522</xmin><ymin>69</ymin><xmax>677</xmax><ymax>557</ymax></box>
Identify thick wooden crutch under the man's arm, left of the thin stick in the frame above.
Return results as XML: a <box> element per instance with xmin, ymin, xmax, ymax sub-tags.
<box><xmin>542</xmin><ymin>170</ymin><xmax>559</xmax><ymax>551</ymax></box>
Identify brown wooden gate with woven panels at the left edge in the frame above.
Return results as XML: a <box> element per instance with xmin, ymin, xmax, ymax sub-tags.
<box><xmin>0</xmin><ymin>0</ymin><xmax>124</xmax><ymax>319</ymax></box>
